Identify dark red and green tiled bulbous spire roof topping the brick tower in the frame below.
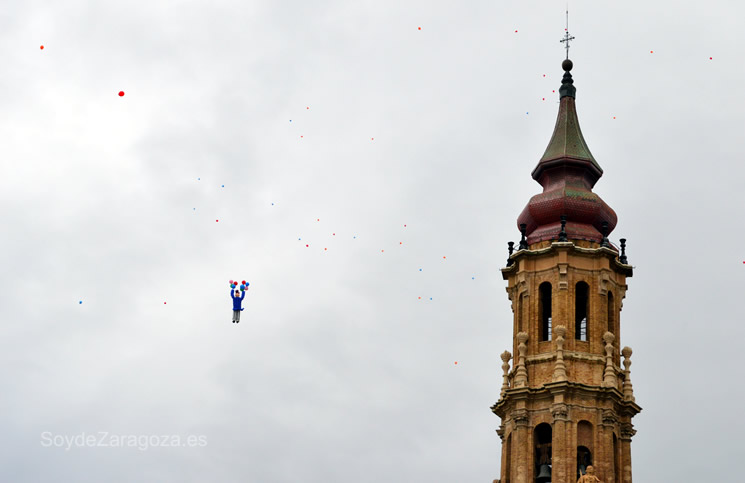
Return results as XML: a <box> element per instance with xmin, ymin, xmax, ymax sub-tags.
<box><xmin>517</xmin><ymin>59</ymin><xmax>618</xmax><ymax>245</ymax></box>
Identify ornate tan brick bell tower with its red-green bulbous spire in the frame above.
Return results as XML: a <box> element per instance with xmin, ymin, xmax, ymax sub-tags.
<box><xmin>491</xmin><ymin>59</ymin><xmax>641</xmax><ymax>483</ymax></box>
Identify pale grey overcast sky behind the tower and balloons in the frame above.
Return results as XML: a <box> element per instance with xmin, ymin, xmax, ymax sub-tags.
<box><xmin>0</xmin><ymin>0</ymin><xmax>745</xmax><ymax>483</ymax></box>
